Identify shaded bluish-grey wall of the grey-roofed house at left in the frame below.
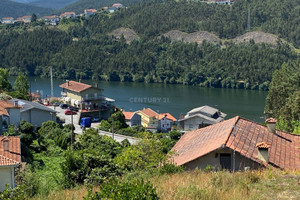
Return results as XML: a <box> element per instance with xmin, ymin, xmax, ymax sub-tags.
<box><xmin>21</xmin><ymin>109</ymin><xmax>56</xmax><ymax>127</ymax></box>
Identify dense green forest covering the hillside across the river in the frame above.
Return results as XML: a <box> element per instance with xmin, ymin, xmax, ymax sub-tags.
<box><xmin>0</xmin><ymin>0</ymin><xmax>300</xmax><ymax>89</ymax></box>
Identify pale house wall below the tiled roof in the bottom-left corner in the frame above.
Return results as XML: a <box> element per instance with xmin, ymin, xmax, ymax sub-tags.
<box><xmin>0</xmin><ymin>166</ymin><xmax>16</xmax><ymax>192</ymax></box>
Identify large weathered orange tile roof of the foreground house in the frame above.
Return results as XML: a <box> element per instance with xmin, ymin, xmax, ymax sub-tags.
<box><xmin>171</xmin><ymin>116</ymin><xmax>300</xmax><ymax>169</ymax></box>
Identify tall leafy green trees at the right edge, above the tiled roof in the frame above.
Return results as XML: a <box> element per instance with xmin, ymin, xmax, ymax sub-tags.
<box><xmin>265</xmin><ymin>59</ymin><xmax>300</xmax><ymax>134</ymax></box>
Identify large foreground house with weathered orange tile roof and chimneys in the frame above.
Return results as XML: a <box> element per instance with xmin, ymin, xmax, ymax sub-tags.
<box><xmin>171</xmin><ymin>116</ymin><xmax>300</xmax><ymax>171</ymax></box>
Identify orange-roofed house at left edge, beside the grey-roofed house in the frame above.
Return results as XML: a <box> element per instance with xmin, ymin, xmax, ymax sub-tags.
<box><xmin>0</xmin><ymin>100</ymin><xmax>21</xmax><ymax>135</ymax></box>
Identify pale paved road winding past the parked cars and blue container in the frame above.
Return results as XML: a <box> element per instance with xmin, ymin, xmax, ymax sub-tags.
<box><xmin>49</xmin><ymin>106</ymin><xmax>139</xmax><ymax>144</ymax></box>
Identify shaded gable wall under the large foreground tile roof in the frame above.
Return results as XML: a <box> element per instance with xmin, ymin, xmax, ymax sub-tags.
<box><xmin>184</xmin><ymin>148</ymin><xmax>260</xmax><ymax>170</ymax></box>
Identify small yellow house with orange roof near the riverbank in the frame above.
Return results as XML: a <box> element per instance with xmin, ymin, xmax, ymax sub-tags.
<box><xmin>136</xmin><ymin>108</ymin><xmax>158</xmax><ymax>130</ymax></box>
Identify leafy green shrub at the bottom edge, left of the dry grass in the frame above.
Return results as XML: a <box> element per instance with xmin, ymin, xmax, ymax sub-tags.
<box><xmin>85</xmin><ymin>180</ymin><xmax>159</xmax><ymax>200</ymax></box>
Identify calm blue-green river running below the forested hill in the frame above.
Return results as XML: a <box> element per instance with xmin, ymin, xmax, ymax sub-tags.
<box><xmin>10</xmin><ymin>77</ymin><xmax>267</xmax><ymax>122</ymax></box>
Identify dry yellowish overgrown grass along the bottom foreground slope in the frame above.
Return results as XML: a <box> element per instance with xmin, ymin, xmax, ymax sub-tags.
<box><xmin>29</xmin><ymin>169</ymin><xmax>300</xmax><ymax>200</ymax></box>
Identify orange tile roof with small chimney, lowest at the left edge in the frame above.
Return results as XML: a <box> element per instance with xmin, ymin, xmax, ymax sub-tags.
<box><xmin>0</xmin><ymin>136</ymin><xmax>21</xmax><ymax>166</ymax></box>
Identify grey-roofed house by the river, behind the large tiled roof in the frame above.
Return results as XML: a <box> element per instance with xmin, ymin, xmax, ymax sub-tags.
<box><xmin>178</xmin><ymin>106</ymin><xmax>226</xmax><ymax>132</ymax></box>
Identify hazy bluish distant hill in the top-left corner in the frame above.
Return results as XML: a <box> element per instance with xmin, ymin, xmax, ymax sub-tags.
<box><xmin>0</xmin><ymin>0</ymin><xmax>52</xmax><ymax>18</ymax></box>
